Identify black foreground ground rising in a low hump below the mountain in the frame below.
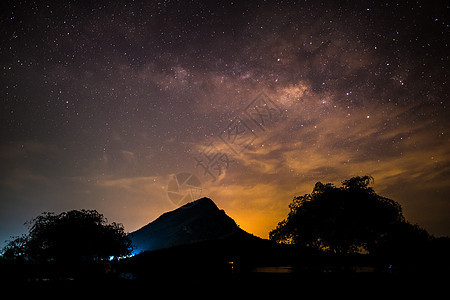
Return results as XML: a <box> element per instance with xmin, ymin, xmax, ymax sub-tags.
<box><xmin>0</xmin><ymin>241</ymin><xmax>450</xmax><ymax>298</ymax></box>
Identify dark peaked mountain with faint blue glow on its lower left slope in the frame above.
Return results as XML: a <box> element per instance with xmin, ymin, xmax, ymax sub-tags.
<box><xmin>129</xmin><ymin>197</ymin><xmax>258</xmax><ymax>253</ymax></box>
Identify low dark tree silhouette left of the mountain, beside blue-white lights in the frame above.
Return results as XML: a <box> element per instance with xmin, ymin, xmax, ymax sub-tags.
<box><xmin>3</xmin><ymin>210</ymin><xmax>131</xmax><ymax>262</ymax></box>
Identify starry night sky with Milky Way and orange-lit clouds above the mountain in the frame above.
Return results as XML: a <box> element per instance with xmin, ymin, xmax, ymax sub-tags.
<box><xmin>0</xmin><ymin>0</ymin><xmax>450</xmax><ymax>244</ymax></box>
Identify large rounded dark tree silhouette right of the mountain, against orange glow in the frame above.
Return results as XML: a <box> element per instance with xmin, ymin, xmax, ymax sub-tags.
<box><xmin>269</xmin><ymin>176</ymin><xmax>404</xmax><ymax>254</ymax></box>
